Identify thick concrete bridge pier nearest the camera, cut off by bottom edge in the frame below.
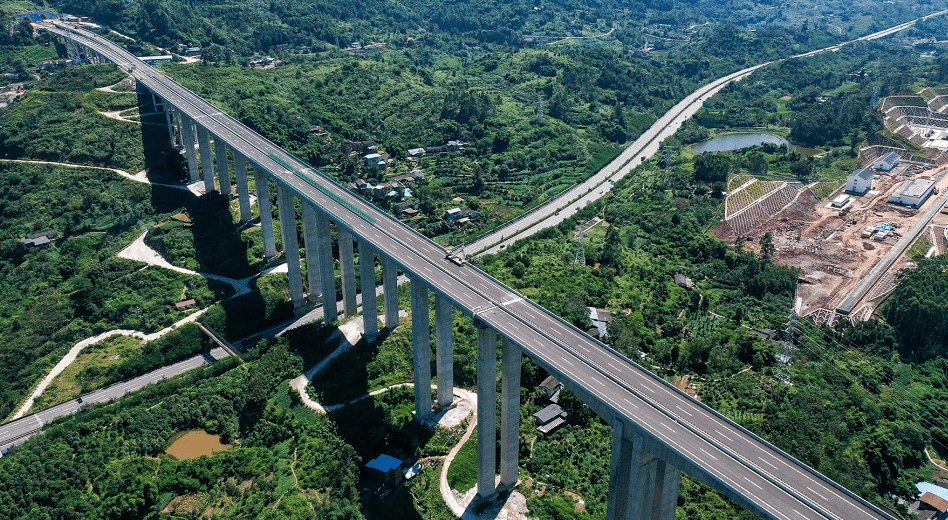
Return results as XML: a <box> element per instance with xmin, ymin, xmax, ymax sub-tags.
<box><xmin>606</xmin><ymin>420</ymin><xmax>681</xmax><ymax>520</ymax></box>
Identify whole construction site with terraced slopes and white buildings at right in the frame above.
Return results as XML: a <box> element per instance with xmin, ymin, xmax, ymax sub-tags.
<box><xmin>713</xmin><ymin>87</ymin><xmax>948</xmax><ymax>324</ymax></box>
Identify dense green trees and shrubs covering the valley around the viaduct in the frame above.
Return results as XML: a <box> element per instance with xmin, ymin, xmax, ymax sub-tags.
<box><xmin>0</xmin><ymin>0</ymin><xmax>948</xmax><ymax>520</ymax></box>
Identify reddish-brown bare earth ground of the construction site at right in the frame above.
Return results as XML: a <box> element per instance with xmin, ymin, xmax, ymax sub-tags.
<box><xmin>713</xmin><ymin>165</ymin><xmax>948</xmax><ymax>315</ymax></box>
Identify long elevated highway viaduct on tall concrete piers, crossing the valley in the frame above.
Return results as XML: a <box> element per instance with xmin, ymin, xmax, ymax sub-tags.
<box><xmin>42</xmin><ymin>22</ymin><xmax>912</xmax><ymax>520</ymax></box>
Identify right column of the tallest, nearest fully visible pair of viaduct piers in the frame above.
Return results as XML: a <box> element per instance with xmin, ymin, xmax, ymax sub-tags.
<box><xmin>500</xmin><ymin>338</ymin><xmax>520</xmax><ymax>490</ymax></box>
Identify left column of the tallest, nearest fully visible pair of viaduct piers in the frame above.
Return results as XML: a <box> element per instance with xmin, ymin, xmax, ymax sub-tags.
<box><xmin>474</xmin><ymin>324</ymin><xmax>497</xmax><ymax>498</ymax></box>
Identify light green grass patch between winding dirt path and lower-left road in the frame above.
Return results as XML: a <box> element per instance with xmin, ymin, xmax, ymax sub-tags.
<box><xmin>31</xmin><ymin>336</ymin><xmax>144</xmax><ymax>410</ymax></box>
